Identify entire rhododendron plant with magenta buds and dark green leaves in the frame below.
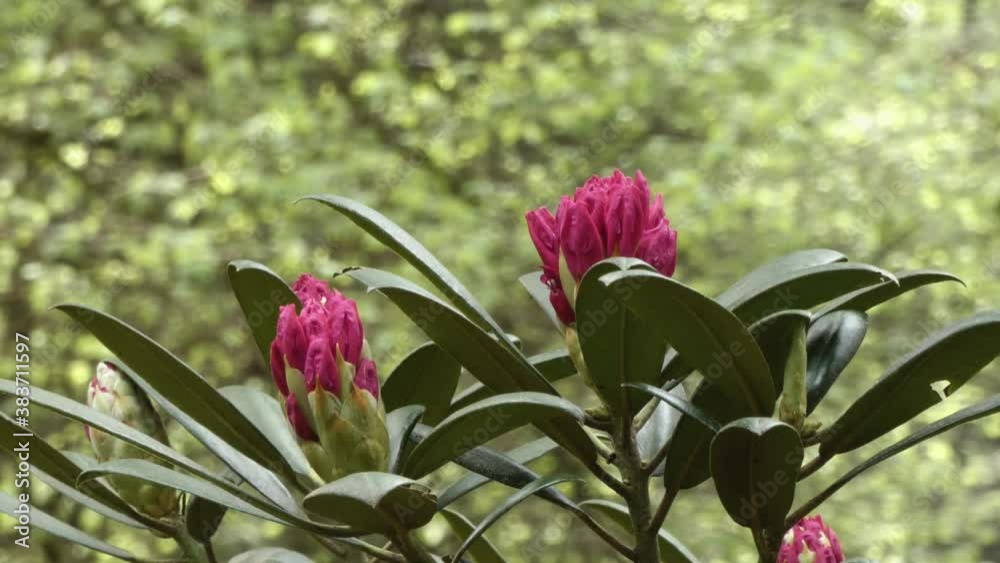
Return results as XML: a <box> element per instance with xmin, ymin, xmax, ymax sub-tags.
<box><xmin>13</xmin><ymin>177</ymin><xmax>1000</xmax><ymax>563</ymax></box>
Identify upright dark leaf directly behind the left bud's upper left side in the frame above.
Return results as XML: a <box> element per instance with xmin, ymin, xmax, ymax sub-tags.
<box><xmin>226</xmin><ymin>260</ymin><xmax>302</xmax><ymax>370</ymax></box>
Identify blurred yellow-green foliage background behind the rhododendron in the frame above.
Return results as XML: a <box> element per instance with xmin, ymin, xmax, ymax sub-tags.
<box><xmin>0</xmin><ymin>0</ymin><xmax>1000</xmax><ymax>563</ymax></box>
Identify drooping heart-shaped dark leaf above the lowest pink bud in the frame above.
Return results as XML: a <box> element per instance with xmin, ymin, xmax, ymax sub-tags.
<box><xmin>711</xmin><ymin>417</ymin><xmax>803</xmax><ymax>531</ymax></box>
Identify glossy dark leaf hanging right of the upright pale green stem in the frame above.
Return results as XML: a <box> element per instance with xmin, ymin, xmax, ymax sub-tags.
<box><xmin>806</xmin><ymin>311</ymin><xmax>868</xmax><ymax>413</ymax></box>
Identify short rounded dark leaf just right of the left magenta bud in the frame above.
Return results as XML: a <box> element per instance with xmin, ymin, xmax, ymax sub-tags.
<box><xmin>382</xmin><ymin>342</ymin><xmax>462</xmax><ymax>425</ymax></box>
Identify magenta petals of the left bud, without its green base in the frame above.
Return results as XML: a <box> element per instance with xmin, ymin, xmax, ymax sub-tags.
<box><xmin>271</xmin><ymin>274</ymin><xmax>379</xmax><ymax>441</ymax></box>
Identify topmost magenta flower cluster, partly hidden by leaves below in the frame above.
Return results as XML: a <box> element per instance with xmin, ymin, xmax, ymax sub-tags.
<box><xmin>525</xmin><ymin>170</ymin><xmax>677</xmax><ymax>325</ymax></box>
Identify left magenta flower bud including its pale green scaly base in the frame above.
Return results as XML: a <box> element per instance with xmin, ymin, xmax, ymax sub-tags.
<box><xmin>271</xmin><ymin>274</ymin><xmax>389</xmax><ymax>480</ymax></box>
